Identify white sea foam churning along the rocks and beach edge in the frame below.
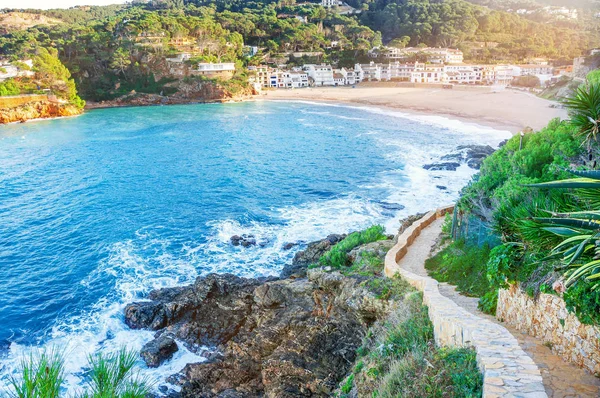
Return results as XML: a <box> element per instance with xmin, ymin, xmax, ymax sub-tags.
<box><xmin>0</xmin><ymin>101</ymin><xmax>510</xmax><ymax>392</ymax></box>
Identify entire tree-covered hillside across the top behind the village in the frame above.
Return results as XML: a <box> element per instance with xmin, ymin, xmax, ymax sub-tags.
<box><xmin>0</xmin><ymin>0</ymin><xmax>598</xmax><ymax>101</ymax></box>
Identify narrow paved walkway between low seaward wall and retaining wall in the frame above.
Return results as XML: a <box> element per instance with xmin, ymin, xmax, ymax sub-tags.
<box><xmin>398</xmin><ymin>218</ymin><xmax>600</xmax><ymax>398</ymax></box>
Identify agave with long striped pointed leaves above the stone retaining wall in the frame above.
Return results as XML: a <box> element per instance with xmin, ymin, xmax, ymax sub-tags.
<box><xmin>530</xmin><ymin>170</ymin><xmax>600</xmax><ymax>287</ymax></box>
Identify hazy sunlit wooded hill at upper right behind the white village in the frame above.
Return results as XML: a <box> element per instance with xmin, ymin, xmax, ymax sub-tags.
<box><xmin>349</xmin><ymin>0</ymin><xmax>597</xmax><ymax>62</ymax></box>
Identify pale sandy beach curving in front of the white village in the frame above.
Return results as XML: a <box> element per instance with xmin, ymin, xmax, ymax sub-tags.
<box><xmin>260</xmin><ymin>83</ymin><xmax>567</xmax><ymax>134</ymax></box>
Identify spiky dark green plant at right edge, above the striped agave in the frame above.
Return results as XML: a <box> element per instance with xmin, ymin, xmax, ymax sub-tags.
<box><xmin>563</xmin><ymin>82</ymin><xmax>600</xmax><ymax>152</ymax></box>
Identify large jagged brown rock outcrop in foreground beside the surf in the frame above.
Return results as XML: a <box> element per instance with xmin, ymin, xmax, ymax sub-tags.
<box><xmin>125</xmin><ymin>225</ymin><xmax>418</xmax><ymax>398</ymax></box>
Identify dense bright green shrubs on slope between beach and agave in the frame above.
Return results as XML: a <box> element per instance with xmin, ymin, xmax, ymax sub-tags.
<box><xmin>457</xmin><ymin>120</ymin><xmax>583</xmax><ymax>243</ymax></box>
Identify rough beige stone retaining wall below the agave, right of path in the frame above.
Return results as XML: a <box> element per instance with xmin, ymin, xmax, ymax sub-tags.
<box><xmin>496</xmin><ymin>285</ymin><xmax>600</xmax><ymax>374</ymax></box>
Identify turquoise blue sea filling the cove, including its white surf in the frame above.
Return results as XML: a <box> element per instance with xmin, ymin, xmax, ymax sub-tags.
<box><xmin>0</xmin><ymin>102</ymin><xmax>508</xmax><ymax>389</ymax></box>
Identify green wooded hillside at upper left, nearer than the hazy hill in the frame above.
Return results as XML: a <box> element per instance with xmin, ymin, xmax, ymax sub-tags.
<box><xmin>0</xmin><ymin>1</ymin><xmax>381</xmax><ymax>100</ymax></box>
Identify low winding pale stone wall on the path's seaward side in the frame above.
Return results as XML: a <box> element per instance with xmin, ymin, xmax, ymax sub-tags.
<box><xmin>385</xmin><ymin>206</ymin><xmax>547</xmax><ymax>398</ymax></box>
